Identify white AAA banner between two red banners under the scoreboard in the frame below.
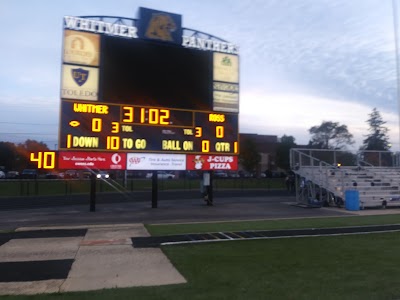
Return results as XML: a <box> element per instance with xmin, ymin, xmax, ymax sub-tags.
<box><xmin>126</xmin><ymin>153</ymin><xmax>186</xmax><ymax>171</ymax></box>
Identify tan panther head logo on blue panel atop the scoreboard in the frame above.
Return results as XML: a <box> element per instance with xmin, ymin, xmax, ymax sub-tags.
<box><xmin>146</xmin><ymin>13</ymin><xmax>176</xmax><ymax>42</ymax></box>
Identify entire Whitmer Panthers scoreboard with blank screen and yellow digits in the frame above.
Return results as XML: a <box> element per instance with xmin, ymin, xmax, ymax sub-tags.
<box><xmin>50</xmin><ymin>8</ymin><xmax>239</xmax><ymax>170</ymax></box>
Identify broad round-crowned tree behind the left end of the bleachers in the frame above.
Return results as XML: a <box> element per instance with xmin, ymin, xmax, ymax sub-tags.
<box><xmin>308</xmin><ymin>121</ymin><xmax>354</xmax><ymax>150</ymax></box>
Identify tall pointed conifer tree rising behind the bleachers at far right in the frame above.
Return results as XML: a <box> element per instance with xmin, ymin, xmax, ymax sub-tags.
<box><xmin>361</xmin><ymin>108</ymin><xmax>390</xmax><ymax>151</ymax></box>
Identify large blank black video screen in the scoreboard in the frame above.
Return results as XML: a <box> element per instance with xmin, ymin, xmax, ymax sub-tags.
<box><xmin>100</xmin><ymin>36</ymin><xmax>212</xmax><ymax>111</ymax></box>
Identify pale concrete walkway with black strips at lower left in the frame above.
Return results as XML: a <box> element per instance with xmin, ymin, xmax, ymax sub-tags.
<box><xmin>0</xmin><ymin>224</ymin><xmax>186</xmax><ymax>295</ymax></box>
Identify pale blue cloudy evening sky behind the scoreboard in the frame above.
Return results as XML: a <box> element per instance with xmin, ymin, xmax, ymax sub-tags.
<box><xmin>0</xmin><ymin>0</ymin><xmax>400</xmax><ymax>150</ymax></box>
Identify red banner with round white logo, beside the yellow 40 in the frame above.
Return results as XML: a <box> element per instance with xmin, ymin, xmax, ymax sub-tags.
<box><xmin>58</xmin><ymin>151</ymin><xmax>126</xmax><ymax>170</ymax></box>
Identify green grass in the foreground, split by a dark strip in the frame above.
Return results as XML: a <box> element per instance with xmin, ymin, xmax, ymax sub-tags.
<box><xmin>4</xmin><ymin>215</ymin><xmax>400</xmax><ymax>300</ymax></box>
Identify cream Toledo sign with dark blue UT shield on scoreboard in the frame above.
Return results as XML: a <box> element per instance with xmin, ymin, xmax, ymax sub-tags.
<box><xmin>61</xmin><ymin>65</ymin><xmax>99</xmax><ymax>101</ymax></box>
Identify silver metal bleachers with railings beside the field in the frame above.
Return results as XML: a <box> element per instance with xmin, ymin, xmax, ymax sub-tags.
<box><xmin>290</xmin><ymin>148</ymin><xmax>400</xmax><ymax>208</ymax></box>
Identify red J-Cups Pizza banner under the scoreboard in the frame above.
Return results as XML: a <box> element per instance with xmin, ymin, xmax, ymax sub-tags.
<box><xmin>186</xmin><ymin>155</ymin><xmax>238</xmax><ymax>171</ymax></box>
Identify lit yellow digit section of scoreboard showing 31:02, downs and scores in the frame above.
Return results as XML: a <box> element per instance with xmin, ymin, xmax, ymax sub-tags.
<box><xmin>60</xmin><ymin>100</ymin><xmax>238</xmax><ymax>154</ymax></box>
